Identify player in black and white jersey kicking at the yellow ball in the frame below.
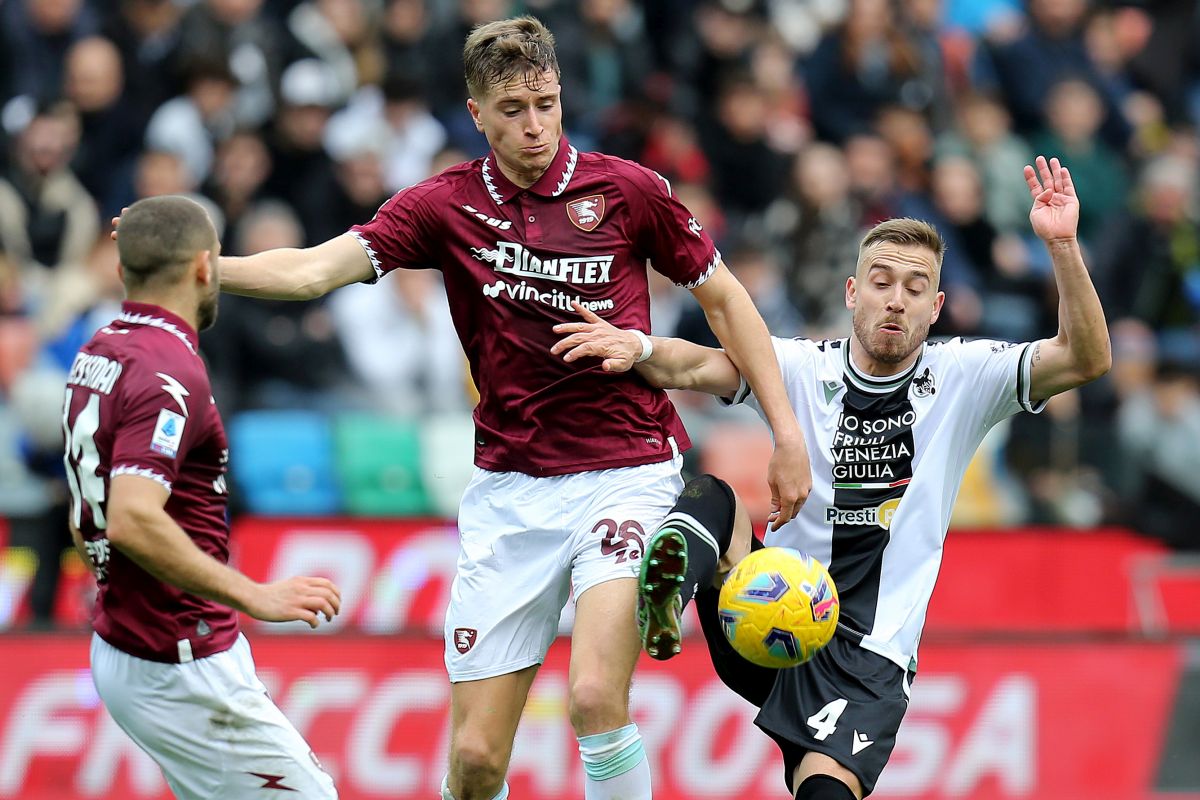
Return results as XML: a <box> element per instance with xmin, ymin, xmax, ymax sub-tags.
<box><xmin>553</xmin><ymin>156</ymin><xmax>1111</xmax><ymax>800</ymax></box>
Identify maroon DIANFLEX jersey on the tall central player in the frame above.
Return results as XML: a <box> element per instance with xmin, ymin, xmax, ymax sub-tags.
<box><xmin>350</xmin><ymin>138</ymin><xmax>720</xmax><ymax>476</ymax></box>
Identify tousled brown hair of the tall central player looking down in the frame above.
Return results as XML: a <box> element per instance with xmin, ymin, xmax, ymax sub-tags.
<box><xmin>462</xmin><ymin>17</ymin><xmax>562</xmax><ymax>100</ymax></box>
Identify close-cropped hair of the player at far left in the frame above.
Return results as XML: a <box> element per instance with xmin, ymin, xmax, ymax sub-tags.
<box><xmin>116</xmin><ymin>194</ymin><xmax>216</xmax><ymax>289</ymax></box>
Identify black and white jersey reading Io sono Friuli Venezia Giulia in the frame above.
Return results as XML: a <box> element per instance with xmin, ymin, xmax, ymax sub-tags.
<box><xmin>726</xmin><ymin>338</ymin><xmax>1045</xmax><ymax>669</ymax></box>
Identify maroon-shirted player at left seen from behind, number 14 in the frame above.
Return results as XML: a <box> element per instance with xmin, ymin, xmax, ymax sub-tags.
<box><xmin>71</xmin><ymin>197</ymin><xmax>341</xmax><ymax>800</ymax></box>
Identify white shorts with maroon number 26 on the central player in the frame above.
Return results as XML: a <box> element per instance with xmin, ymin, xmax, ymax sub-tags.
<box><xmin>445</xmin><ymin>455</ymin><xmax>683</xmax><ymax>682</ymax></box>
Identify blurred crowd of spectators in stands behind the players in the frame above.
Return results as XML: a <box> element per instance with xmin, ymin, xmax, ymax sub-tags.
<box><xmin>0</xmin><ymin>0</ymin><xmax>1200</xmax><ymax>623</ymax></box>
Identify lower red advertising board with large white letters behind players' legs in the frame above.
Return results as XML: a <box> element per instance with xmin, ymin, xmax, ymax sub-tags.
<box><xmin>0</xmin><ymin>636</ymin><xmax>1185</xmax><ymax>800</ymax></box>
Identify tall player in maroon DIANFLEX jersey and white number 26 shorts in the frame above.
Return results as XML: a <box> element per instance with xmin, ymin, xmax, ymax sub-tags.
<box><xmin>114</xmin><ymin>17</ymin><xmax>812</xmax><ymax>800</ymax></box>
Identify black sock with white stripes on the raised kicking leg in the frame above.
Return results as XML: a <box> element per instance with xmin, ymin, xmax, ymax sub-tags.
<box><xmin>659</xmin><ymin>475</ymin><xmax>737</xmax><ymax>606</ymax></box>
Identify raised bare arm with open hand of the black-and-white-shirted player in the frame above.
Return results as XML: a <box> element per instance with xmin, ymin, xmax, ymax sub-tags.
<box><xmin>1025</xmin><ymin>156</ymin><xmax>1112</xmax><ymax>401</ymax></box>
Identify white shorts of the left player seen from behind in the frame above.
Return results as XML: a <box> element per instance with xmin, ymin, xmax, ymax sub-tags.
<box><xmin>91</xmin><ymin>634</ymin><xmax>337</xmax><ymax>800</ymax></box>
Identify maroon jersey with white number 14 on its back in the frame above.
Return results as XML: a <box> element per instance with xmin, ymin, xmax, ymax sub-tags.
<box><xmin>62</xmin><ymin>302</ymin><xmax>238</xmax><ymax>662</ymax></box>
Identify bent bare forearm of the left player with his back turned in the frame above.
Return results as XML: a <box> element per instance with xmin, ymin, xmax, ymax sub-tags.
<box><xmin>108</xmin><ymin>475</ymin><xmax>342</xmax><ymax>627</ymax></box>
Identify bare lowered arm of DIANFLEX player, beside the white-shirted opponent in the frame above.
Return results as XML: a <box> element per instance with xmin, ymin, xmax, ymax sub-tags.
<box><xmin>691</xmin><ymin>261</ymin><xmax>812</xmax><ymax>530</ymax></box>
